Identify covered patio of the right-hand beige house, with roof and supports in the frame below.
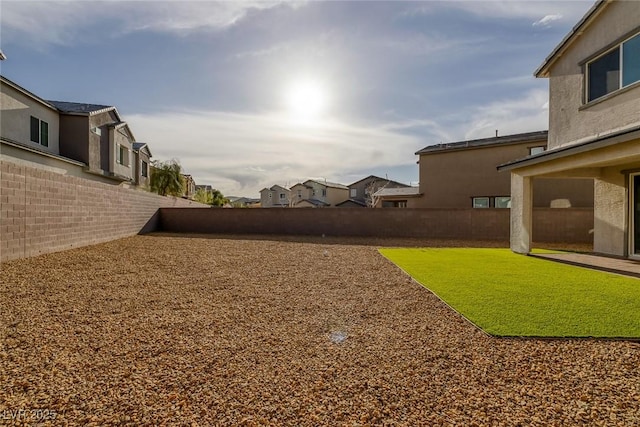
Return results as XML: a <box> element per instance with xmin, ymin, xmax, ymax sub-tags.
<box><xmin>498</xmin><ymin>126</ymin><xmax>640</xmax><ymax>259</ymax></box>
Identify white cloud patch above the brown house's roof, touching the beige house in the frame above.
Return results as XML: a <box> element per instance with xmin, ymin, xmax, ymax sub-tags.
<box><xmin>464</xmin><ymin>89</ymin><xmax>549</xmax><ymax>139</ymax></box>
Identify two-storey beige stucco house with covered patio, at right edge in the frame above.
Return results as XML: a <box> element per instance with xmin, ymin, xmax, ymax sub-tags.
<box><xmin>499</xmin><ymin>1</ymin><xmax>640</xmax><ymax>259</ymax></box>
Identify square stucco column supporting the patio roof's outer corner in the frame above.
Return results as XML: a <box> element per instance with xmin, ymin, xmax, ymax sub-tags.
<box><xmin>511</xmin><ymin>172</ymin><xmax>533</xmax><ymax>254</ymax></box>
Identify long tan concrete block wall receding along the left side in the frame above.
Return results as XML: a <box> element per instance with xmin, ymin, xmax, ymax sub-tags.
<box><xmin>0</xmin><ymin>156</ymin><xmax>204</xmax><ymax>261</ymax></box>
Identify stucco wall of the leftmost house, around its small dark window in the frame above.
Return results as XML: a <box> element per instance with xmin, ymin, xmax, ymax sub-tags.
<box><xmin>0</xmin><ymin>83</ymin><xmax>60</xmax><ymax>154</ymax></box>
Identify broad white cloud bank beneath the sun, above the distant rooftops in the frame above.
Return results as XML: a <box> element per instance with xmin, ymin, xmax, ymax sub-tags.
<box><xmin>126</xmin><ymin>111</ymin><xmax>424</xmax><ymax>196</ymax></box>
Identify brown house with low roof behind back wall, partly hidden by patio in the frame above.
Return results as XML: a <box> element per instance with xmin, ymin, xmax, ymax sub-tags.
<box><xmin>409</xmin><ymin>131</ymin><xmax>593</xmax><ymax>208</ymax></box>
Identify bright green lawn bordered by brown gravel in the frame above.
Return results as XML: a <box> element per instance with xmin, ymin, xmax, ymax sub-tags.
<box><xmin>380</xmin><ymin>248</ymin><xmax>640</xmax><ymax>338</ymax></box>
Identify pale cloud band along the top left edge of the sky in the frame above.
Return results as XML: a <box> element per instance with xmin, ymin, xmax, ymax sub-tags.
<box><xmin>0</xmin><ymin>0</ymin><xmax>304</xmax><ymax>46</ymax></box>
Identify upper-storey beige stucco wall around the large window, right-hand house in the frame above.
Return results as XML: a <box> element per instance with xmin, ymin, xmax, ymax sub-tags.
<box><xmin>549</xmin><ymin>1</ymin><xmax>640</xmax><ymax>148</ymax></box>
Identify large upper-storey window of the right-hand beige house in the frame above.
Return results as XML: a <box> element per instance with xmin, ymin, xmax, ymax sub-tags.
<box><xmin>586</xmin><ymin>34</ymin><xmax>640</xmax><ymax>101</ymax></box>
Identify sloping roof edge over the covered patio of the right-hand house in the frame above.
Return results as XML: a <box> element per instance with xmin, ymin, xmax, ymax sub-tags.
<box><xmin>497</xmin><ymin>125</ymin><xmax>640</xmax><ymax>171</ymax></box>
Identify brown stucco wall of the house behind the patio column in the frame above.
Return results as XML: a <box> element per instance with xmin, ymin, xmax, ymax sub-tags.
<box><xmin>416</xmin><ymin>140</ymin><xmax>593</xmax><ymax>208</ymax></box>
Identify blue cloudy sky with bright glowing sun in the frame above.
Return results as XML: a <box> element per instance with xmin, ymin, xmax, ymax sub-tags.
<box><xmin>0</xmin><ymin>0</ymin><xmax>593</xmax><ymax>198</ymax></box>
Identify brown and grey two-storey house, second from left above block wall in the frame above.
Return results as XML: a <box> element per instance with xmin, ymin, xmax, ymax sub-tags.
<box><xmin>49</xmin><ymin>101</ymin><xmax>135</xmax><ymax>182</ymax></box>
